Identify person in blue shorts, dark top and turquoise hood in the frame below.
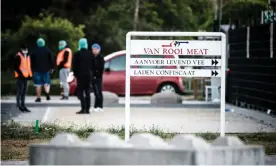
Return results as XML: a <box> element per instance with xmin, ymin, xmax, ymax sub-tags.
<box><xmin>31</xmin><ymin>38</ymin><xmax>55</xmax><ymax>102</ymax></box>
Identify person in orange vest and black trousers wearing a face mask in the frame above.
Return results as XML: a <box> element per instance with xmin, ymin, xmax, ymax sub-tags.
<box><xmin>14</xmin><ymin>45</ymin><xmax>33</xmax><ymax>112</ymax></box>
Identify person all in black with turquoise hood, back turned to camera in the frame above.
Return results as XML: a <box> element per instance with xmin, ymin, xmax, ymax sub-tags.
<box><xmin>72</xmin><ymin>38</ymin><xmax>94</xmax><ymax>114</ymax></box>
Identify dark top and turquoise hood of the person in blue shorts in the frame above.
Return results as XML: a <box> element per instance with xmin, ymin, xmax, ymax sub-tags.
<box><xmin>31</xmin><ymin>38</ymin><xmax>54</xmax><ymax>72</ymax></box>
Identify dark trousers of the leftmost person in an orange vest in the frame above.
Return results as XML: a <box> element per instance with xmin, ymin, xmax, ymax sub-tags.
<box><xmin>16</xmin><ymin>79</ymin><xmax>28</xmax><ymax>107</ymax></box>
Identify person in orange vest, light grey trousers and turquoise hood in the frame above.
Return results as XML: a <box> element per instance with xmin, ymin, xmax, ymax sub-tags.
<box><xmin>56</xmin><ymin>40</ymin><xmax>72</xmax><ymax>100</ymax></box>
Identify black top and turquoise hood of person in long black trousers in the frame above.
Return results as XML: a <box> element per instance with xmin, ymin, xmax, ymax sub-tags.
<box><xmin>72</xmin><ymin>38</ymin><xmax>95</xmax><ymax>78</ymax></box>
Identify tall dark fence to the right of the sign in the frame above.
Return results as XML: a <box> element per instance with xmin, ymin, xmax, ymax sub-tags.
<box><xmin>226</xmin><ymin>24</ymin><xmax>276</xmax><ymax>113</ymax></box>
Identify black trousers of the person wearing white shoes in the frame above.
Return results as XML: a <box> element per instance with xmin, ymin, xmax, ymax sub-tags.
<box><xmin>92</xmin><ymin>79</ymin><xmax>103</xmax><ymax>108</ymax></box>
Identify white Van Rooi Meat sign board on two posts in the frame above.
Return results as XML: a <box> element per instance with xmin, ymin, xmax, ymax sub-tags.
<box><xmin>125</xmin><ymin>32</ymin><xmax>226</xmax><ymax>140</ymax></box>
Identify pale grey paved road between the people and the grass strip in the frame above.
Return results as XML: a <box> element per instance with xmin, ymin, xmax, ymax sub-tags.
<box><xmin>1</xmin><ymin>98</ymin><xmax>276</xmax><ymax>165</ymax></box>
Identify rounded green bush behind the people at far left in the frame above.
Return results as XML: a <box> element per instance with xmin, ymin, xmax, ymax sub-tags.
<box><xmin>1</xmin><ymin>13</ymin><xmax>84</xmax><ymax>69</ymax></box>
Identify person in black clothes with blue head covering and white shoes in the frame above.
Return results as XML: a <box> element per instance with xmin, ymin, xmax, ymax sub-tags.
<box><xmin>92</xmin><ymin>44</ymin><xmax>104</xmax><ymax>112</ymax></box>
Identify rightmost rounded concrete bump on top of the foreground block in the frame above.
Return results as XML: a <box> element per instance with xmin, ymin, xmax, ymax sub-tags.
<box><xmin>211</xmin><ymin>136</ymin><xmax>244</xmax><ymax>146</ymax></box>
